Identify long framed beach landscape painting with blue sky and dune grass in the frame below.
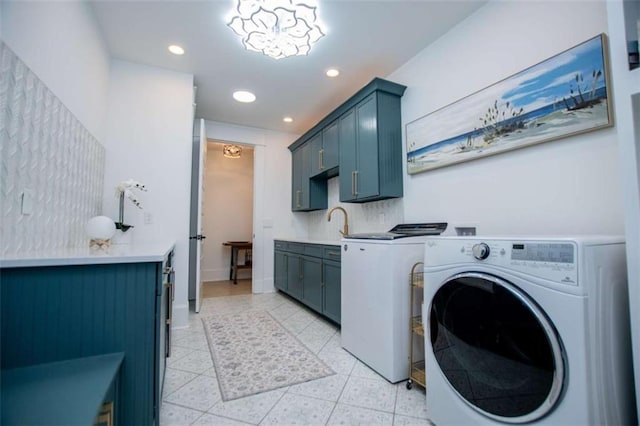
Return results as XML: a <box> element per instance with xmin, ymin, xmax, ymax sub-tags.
<box><xmin>406</xmin><ymin>34</ymin><xmax>613</xmax><ymax>174</ymax></box>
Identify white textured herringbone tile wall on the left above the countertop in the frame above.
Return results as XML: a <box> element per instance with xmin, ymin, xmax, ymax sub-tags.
<box><xmin>0</xmin><ymin>41</ymin><xmax>105</xmax><ymax>256</ymax></box>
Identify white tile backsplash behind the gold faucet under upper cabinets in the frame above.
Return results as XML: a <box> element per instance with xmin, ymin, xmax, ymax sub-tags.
<box><xmin>302</xmin><ymin>177</ymin><xmax>404</xmax><ymax>241</ymax></box>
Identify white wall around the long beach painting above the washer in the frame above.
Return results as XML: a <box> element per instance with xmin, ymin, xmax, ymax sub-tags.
<box><xmin>388</xmin><ymin>1</ymin><xmax>624</xmax><ymax>234</ymax></box>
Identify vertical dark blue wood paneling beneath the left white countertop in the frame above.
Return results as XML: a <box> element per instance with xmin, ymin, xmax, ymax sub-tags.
<box><xmin>0</xmin><ymin>262</ymin><xmax>162</xmax><ymax>425</ymax></box>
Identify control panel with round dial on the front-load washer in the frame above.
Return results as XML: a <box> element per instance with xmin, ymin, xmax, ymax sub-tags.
<box><xmin>425</xmin><ymin>237</ymin><xmax>578</xmax><ymax>286</ymax></box>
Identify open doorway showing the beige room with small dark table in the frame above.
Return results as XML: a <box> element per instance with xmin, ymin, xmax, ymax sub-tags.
<box><xmin>201</xmin><ymin>140</ymin><xmax>254</xmax><ymax>299</ymax></box>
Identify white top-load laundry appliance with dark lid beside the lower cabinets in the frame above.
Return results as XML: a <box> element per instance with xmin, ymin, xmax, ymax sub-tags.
<box><xmin>341</xmin><ymin>223</ymin><xmax>447</xmax><ymax>383</ymax></box>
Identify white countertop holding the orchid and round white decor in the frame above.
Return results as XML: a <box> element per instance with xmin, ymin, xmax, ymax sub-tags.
<box><xmin>0</xmin><ymin>242</ymin><xmax>175</xmax><ymax>268</ymax></box>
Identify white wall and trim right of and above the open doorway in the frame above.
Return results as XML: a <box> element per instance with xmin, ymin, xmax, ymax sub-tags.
<box><xmin>205</xmin><ymin>121</ymin><xmax>300</xmax><ymax>293</ymax></box>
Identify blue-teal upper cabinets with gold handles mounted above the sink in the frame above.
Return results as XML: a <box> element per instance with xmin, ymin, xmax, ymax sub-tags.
<box><xmin>289</xmin><ymin>78</ymin><xmax>406</xmax><ymax>211</ymax></box>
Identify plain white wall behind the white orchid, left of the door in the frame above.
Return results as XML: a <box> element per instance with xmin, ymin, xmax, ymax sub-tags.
<box><xmin>103</xmin><ymin>60</ymin><xmax>193</xmax><ymax>327</ymax></box>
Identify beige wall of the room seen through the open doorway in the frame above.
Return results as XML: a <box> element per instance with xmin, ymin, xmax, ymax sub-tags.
<box><xmin>202</xmin><ymin>142</ymin><xmax>253</xmax><ymax>281</ymax></box>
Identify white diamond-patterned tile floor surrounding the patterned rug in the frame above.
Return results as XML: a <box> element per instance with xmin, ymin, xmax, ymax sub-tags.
<box><xmin>160</xmin><ymin>293</ymin><xmax>430</xmax><ymax>426</ymax></box>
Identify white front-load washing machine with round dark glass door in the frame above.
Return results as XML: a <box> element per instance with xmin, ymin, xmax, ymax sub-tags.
<box><xmin>423</xmin><ymin>237</ymin><xmax>637</xmax><ymax>426</ymax></box>
